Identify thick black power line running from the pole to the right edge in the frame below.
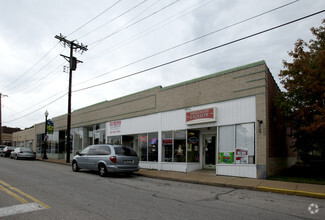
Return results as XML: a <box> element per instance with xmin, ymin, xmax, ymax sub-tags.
<box><xmin>73</xmin><ymin>10</ymin><xmax>325</xmax><ymax>92</ymax></box>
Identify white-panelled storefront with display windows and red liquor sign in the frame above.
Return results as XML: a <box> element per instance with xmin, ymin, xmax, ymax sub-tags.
<box><xmin>106</xmin><ymin>96</ymin><xmax>256</xmax><ymax>178</ymax></box>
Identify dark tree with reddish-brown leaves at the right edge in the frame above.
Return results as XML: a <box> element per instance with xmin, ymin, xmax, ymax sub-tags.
<box><xmin>275</xmin><ymin>20</ymin><xmax>325</xmax><ymax>161</ymax></box>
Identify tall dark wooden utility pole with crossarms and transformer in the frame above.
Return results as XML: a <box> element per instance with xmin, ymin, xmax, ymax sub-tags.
<box><xmin>55</xmin><ymin>34</ymin><xmax>88</xmax><ymax>163</ymax></box>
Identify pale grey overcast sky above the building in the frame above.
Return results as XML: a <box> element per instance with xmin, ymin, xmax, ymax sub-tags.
<box><xmin>0</xmin><ymin>0</ymin><xmax>325</xmax><ymax>129</ymax></box>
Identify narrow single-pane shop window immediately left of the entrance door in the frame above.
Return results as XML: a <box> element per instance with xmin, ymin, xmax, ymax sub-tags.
<box><xmin>187</xmin><ymin>130</ymin><xmax>200</xmax><ymax>163</ymax></box>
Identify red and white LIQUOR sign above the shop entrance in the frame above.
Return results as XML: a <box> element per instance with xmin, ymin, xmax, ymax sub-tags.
<box><xmin>186</xmin><ymin>108</ymin><xmax>216</xmax><ymax>124</ymax></box>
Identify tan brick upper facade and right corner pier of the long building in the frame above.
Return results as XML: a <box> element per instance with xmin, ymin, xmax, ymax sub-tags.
<box><xmin>13</xmin><ymin>61</ymin><xmax>269</xmax><ymax>176</ymax></box>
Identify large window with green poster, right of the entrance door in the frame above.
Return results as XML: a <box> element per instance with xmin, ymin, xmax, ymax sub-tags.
<box><xmin>218</xmin><ymin>123</ymin><xmax>255</xmax><ymax>164</ymax></box>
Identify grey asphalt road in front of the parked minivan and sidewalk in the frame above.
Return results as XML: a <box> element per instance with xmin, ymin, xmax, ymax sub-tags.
<box><xmin>0</xmin><ymin>158</ymin><xmax>325</xmax><ymax>220</ymax></box>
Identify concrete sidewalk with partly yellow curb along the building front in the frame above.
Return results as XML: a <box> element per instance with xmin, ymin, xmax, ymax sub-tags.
<box><xmin>38</xmin><ymin>159</ymin><xmax>325</xmax><ymax>199</ymax></box>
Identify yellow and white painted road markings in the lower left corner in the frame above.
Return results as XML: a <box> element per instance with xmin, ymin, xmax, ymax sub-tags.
<box><xmin>0</xmin><ymin>180</ymin><xmax>51</xmax><ymax>217</ymax></box>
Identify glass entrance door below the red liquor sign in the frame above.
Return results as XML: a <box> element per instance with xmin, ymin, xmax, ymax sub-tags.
<box><xmin>203</xmin><ymin>135</ymin><xmax>216</xmax><ymax>169</ymax></box>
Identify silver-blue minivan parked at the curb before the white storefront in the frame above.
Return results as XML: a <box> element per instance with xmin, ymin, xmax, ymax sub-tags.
<box><xmin>72</xmin><ymin>144</ymin><xmax>140</xmax><ymax>176</ymax></box>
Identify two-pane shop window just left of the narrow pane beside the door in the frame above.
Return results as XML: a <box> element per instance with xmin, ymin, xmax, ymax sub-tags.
<box><xmin>162</xmin><ymin>130</ymin><xmax>186</xmax><ymax>162</ymax></box>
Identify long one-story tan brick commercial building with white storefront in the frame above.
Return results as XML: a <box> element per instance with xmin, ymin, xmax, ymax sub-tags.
<box><xmin>13</xmin><ymin>61</ymin><xmax>296</xmax><ymax>178</ymax></box>
